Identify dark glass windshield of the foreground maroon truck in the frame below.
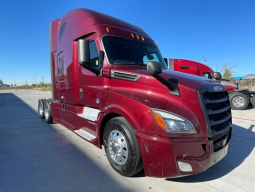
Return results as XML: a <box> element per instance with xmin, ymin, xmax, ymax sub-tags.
<box><xmin>103</xmin><ymin>36</ymin><xmax>167</xmax><ymax>69</ymax></box>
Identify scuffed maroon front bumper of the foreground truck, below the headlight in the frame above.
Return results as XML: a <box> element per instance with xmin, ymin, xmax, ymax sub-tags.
<box><xmin>137</xmin><ymin>131</ymin><xmax>231</xmax><ymax>178</ymax></box>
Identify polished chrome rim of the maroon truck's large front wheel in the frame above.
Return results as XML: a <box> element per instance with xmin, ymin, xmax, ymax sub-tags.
<box><xmin>107</xmin><ymin>130</ymin><xmax>128</xmax><ymax>165</ymax></box>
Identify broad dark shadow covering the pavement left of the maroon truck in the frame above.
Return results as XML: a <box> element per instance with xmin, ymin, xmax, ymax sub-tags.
<box><xmin>0</xmin><ymin>93</ymin><xmax>126</xmax><ymax>192</ymax></box>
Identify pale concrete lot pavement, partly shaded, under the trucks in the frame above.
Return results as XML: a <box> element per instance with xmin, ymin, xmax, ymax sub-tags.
<box><xmin>0</xmin><ymin>90</ymin><xmax>255</xmax><ymax>192</ymax></box>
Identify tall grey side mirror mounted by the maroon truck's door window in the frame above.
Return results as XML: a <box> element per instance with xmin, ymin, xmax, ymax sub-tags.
<box><xmin>78</xmin><ymin>39</ymin><xmax>90</xmax><ymax>67</ymax></box>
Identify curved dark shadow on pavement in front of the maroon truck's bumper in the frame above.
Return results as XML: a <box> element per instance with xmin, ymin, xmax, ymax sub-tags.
<box><xmin>166</xmin><ymin>124</ymin><xmax>255</xmax><ymax>183</ymax></box>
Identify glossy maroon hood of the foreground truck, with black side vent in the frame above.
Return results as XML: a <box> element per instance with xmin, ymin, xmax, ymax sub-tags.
<box><xmin>110</xmin><ymin>65</ymin><xmax>218</xmax><ymax>137</ymax></box>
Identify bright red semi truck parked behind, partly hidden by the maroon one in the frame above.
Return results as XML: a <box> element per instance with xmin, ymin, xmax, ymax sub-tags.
<box><xmin>165</xmin><ymin>59</ymin><xmax>255</xmax><ymax>110</ymax></box>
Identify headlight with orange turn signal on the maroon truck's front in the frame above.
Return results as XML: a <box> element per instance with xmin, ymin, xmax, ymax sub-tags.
<box><xmin>151</xmin><ymin>109</ymin><xmax>196</xmax><ymax>133</ymax></box>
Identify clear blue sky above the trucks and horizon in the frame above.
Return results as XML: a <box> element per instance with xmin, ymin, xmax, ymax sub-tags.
<box><xmin>0</xmin><ymin>0</ymin><xmax>255</xmax><ymax>84</ymax></box>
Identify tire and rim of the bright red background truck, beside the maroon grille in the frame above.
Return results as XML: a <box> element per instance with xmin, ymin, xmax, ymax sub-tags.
<box><xmin>229</xmin><ymin>92</ymin><xmax>249</xmax><ymax>110</ymax></box>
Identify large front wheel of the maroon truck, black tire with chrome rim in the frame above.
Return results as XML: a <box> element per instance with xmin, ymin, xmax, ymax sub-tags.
<box><xmin>103</xmin><ymin>117</ymin><xmax>143</xmax><ymax>177</ymax></box>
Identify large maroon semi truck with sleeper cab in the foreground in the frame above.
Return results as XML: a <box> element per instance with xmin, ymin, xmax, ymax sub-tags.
<box><xmin>38</xmin><ymin>9</ymin><xmax>232</xmax><ymax>178</ymax></box>
